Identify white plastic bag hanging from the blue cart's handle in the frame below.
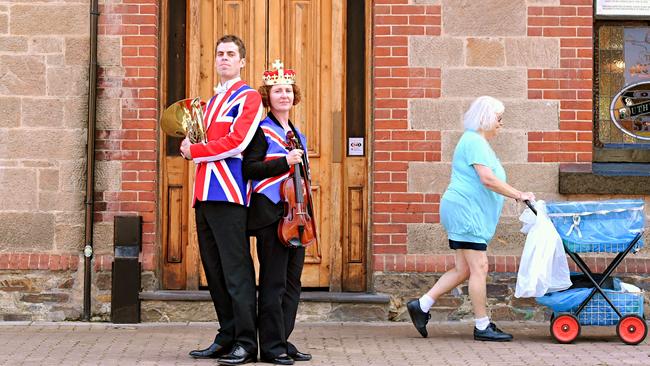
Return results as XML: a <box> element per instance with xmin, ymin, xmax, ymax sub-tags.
<box><xmin>515</xmin><ymin>201</ymin><xmax>571</xmax><ymax>297</ymax></box>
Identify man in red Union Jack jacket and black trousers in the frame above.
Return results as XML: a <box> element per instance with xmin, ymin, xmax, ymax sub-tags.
<box><xmin>181</xmin><ymin>35</ymin><xmax>263</xmax><ymax>365</ymax></box>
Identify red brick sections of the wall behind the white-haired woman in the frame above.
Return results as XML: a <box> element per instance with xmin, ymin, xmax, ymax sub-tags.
<box><xmin>371</xmin><ymin>0</ymin><xmax>596</xmax><ymax>272</ymax></box>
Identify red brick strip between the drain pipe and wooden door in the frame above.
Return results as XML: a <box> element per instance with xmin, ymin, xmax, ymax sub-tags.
<box><xmin>95</xmin><ymin>0</ymin><xmax>159</xmax><ymax>270</ymax></box>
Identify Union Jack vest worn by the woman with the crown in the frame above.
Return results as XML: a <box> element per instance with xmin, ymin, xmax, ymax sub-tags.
<box><xmin>251</xmin><ymin>117</ymin><xmax>307</xmax><ymax>203</ymax></box>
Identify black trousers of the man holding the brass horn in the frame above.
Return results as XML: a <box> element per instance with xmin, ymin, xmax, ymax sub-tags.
<box><xmin>196</xmin><ymin>201</ymin><xmax>257</xmax><ymax>354</ymax></box>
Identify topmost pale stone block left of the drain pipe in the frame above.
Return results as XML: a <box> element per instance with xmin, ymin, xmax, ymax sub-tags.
<box><xmin>9</xmin><ymin>4</ymin><xmax>89</xmax><ymax>35</ymax></box>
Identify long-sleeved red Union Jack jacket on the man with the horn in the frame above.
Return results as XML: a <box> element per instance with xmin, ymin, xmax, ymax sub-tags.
<box><xmin>190</xmin><ymin>81</ymin><xmax>263</xmax><ymax>207</ymax></box>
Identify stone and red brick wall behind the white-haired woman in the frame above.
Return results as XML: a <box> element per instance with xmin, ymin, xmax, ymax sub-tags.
<box><xmin>371</xmin><ymin>0</ymin><xmax>646</xmax><ymax>285</ymax></box>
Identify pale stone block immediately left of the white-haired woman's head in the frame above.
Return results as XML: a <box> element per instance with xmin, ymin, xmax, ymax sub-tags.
<box><xmin>409</xmin><ymin>99</ymin><xmax>464</xmax><ymax>130</ymax></box>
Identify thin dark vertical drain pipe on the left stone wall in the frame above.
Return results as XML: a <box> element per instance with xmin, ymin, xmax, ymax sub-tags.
<box><xmin>83</xmin><ymin>0</ymin><xmax>99</xmax><ymax>321</ymax></box>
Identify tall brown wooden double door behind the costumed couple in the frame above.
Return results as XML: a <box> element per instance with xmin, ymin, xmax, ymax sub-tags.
<box><xmin>162</xmin><ymin>0</ymin><xmax>365</xmax><ymax>290</ymax></box>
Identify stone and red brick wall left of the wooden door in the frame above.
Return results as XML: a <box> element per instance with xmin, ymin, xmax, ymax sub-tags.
<box><xmin>0</xmin><ymin>0</ymin><xmax>159</xmax><ymax>320</ymax></box>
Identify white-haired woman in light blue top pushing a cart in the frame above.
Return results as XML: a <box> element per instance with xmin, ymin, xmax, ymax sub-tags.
<box><xmin>407</xmin><ymin>96</ymin><xmax>535</xmax><ymax>341</ymax></box>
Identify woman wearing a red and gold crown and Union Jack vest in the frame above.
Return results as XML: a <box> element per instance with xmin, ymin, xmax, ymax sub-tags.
<box><xmin>243</xmin><ymin>60</ymin><xmax>311</xmax><ymax>365</ymax></box>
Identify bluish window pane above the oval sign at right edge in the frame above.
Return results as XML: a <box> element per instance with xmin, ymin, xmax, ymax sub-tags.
<box><xmin>623</xmin><ymin>28</ymin><xmax>650</xmax><ymax>85</ymax></box>
